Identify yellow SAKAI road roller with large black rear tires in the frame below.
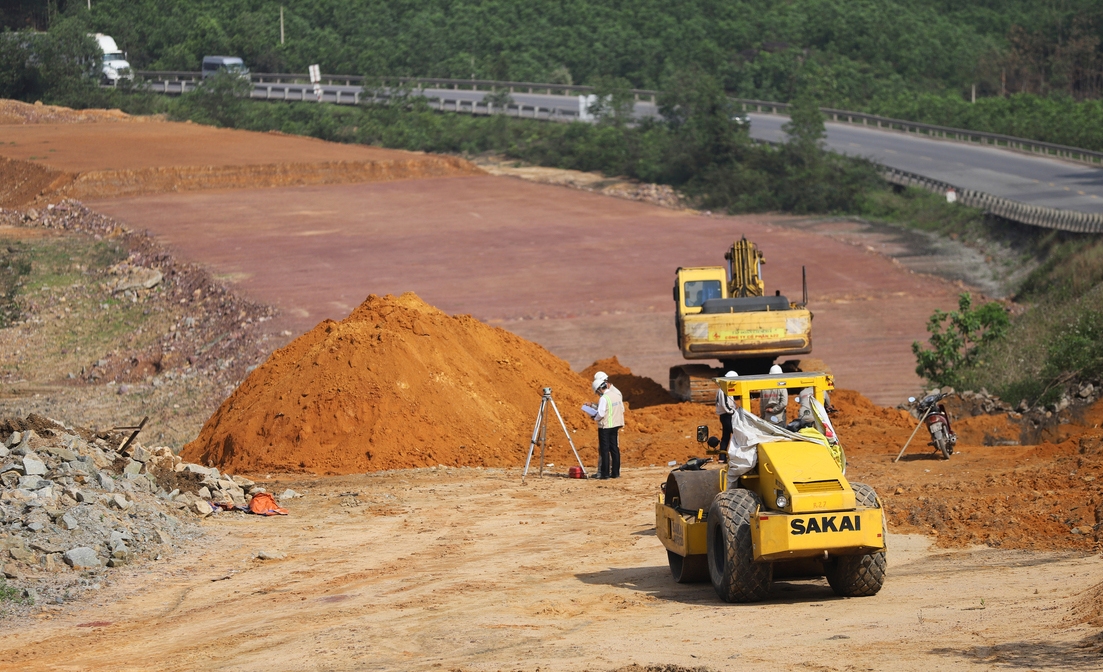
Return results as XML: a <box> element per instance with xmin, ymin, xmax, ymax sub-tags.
<box><xmin>655</xmin><ymin>372</ymin><xmax>887</xmax><ymax>602</ymax></box>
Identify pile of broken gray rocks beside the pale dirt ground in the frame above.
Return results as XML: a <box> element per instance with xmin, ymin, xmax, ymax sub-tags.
<box><xmin>0</xmin><ymin>414</ymin><xmax>275</xmax><ymax>609</ymax></box>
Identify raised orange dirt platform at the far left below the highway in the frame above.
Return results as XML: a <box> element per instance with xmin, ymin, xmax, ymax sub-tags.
<box><xmin>0</xmin><ymin>102</ymin><xmax>482</xmax><ymax>206</ymax></box>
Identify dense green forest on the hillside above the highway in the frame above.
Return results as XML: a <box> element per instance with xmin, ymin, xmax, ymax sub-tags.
<box><xmin>0</xmin><ymin>0</ymin><xmax>1103</xmax><ymax>107</ymax></box>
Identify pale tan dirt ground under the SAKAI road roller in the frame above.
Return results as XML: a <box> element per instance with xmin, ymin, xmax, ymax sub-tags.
<box><xmin>0</xmin><ymin>468</ymin><xmax>1103</xmax><ymax>671</ymax></box>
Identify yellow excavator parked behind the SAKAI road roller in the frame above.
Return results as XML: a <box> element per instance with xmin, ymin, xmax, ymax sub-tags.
<box><xmin>671</xmin><ymin>237</ymin><xmax>812</xmax><ymax>403</ymax></box>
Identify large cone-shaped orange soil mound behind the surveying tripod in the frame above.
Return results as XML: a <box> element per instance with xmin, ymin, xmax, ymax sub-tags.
<box><xmin>182</xmin><ymin>294</ymin><xmax>595</xmax><ymax>473</ymax></box>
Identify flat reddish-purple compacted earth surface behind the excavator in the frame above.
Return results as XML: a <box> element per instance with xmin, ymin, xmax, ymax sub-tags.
<box><xmin>89</xmin><ymin>177</ymin><xmax>961</xmax><ymax>404</ymax></box>
